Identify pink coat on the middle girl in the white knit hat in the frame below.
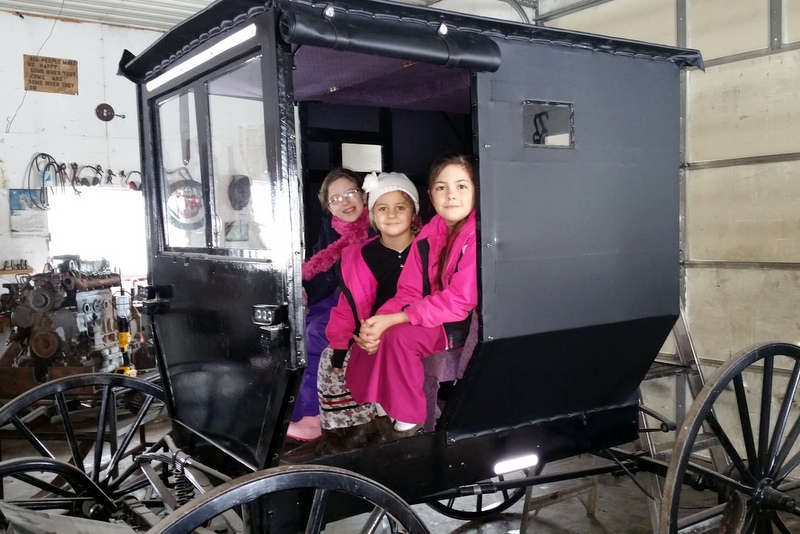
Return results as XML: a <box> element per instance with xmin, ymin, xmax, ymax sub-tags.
<box><xmin>325</xmin><ymin>238</ymin><xmax>380</xmax><ymax>350</ymax></box>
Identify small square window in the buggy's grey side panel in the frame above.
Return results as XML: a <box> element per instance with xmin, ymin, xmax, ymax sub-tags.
<box><xmin>522</xmin><ymin>100</ymin><xmax>575</xmax><ymax>148</ymax></box>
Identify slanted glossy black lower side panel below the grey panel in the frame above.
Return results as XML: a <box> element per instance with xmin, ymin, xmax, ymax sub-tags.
<box><xmin>439</xmin><ymin>316</ymin><xmax>675</xmax><ymax>438</ymax></box>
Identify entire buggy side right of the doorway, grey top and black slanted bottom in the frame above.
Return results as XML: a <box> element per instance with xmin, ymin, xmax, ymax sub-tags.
<box><xmin>442</xmin><ymin>36</ymin><xmax>680</xmax><ymax>440</ymax></box>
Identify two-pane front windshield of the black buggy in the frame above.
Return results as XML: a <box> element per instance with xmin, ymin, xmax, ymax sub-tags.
<box><xmin>158</xmin><ymin>57</ymin><xmax>286</xmax><ymax>258</ymax></box>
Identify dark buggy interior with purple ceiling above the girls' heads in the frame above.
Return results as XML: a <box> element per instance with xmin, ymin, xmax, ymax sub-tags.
<box><xmin>293</xmin><ymin>45</ymin><xmax>472</xmax><ymax>245</ymax></box>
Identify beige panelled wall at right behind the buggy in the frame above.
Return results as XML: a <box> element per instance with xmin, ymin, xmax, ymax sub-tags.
<box><xmin>551</xmin><ymin>0</ymin><xmax>800</xmax><ymax>460</ymax></box>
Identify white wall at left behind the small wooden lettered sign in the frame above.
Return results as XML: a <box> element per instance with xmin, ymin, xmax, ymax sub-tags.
<box><xmin>0</xmin><ymin>11</ymin><xmax>160</xmax><ymax>271</ymax></box>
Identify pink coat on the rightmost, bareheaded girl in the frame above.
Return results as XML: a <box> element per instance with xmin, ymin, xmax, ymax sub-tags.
<box><xmin>380</xmin><ymin>211</ymin><xmax>478</xmax><ymax>344</ymax></box>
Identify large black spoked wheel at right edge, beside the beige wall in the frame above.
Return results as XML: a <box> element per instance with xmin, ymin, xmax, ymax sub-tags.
<box><xmin>660</xmin><ymin>343</ymin><xmax>800</xmax><ymax>534</ymax></box>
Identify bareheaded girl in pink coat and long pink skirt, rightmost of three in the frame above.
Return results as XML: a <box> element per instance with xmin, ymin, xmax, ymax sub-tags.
<box><xmin>347</xmin><ymin>154</ymin><xmax>478</xmax><ymax>440</ymax></box>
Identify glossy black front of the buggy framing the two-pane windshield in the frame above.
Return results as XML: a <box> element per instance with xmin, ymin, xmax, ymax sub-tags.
<box><xmin>131</xmin><ymin>3</ymin><xmax>305</xmax><ymax>471</ymax></box>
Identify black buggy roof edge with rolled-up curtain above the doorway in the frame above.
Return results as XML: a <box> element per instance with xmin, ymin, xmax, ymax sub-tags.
<box><xmin>120</xmin><ymin>0</ymin><xmax>703</xmax><ymax>91</ymax></box>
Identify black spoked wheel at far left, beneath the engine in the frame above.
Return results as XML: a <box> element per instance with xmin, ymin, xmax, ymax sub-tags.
<box><xmin>0</xmin><ymin>374</ymin><xmax>166</xmax><ymax>515</ymax></box>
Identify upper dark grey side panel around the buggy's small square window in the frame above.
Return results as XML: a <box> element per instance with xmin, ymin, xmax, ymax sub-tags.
<box><xmin>476</xmin><ymin>38</ymin><xmax>680</xmax><ymax>339</ymax></box>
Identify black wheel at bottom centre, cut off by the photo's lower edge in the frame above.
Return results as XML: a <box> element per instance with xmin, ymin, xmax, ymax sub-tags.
<box><xmin>148</xmin><ymin>465</ymin><xmax>429</xmax><ymax>534</ymax></box>
